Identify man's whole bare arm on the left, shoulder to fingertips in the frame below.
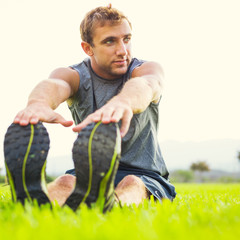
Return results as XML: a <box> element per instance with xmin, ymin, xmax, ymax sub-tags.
<box><xmin>14</xmin><ymin>68</ymin><xmax>79</xmax><ymax>127</ymax></box>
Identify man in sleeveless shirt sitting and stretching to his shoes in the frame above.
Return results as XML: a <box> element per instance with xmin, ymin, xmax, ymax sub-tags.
<box><xmin>4</xmin><ymin>5</ymin><xmax>176</xmax><ymax>211</ymax></box>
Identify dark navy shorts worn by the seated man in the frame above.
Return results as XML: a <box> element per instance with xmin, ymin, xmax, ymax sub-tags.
<box><xmin>66</xmin><ymin>164</ymin><xmax>176</xmax><ymax>201</ymax></box>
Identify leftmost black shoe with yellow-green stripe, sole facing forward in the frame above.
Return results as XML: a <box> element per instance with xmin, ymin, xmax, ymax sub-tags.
<box><xmin>4</xmin><ymin>122</ymin><xmax>50</xmax><ymax>205</ymax></box>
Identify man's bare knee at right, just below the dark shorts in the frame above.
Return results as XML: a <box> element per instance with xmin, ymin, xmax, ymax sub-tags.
<box><xmin>115</xmin><ymin>175</ymin><xmax>150</xmax><ymax>205</ymax></box>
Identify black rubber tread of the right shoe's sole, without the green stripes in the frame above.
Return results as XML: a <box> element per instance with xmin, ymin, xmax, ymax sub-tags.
<box><xmin>66</xmin><ymin>123</ymin><xmax>120</xmax><ymax>210</ymax></box>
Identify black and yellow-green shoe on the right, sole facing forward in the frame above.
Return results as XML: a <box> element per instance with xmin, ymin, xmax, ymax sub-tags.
<box><xmin>65</xmin><ymin>122</ymin><xmax>121</xmax><ymax>212</ymax></box>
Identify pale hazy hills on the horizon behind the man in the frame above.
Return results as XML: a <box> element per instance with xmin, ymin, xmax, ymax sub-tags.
<box><xmin>44</xmin><ymin>139</ymin><xmax>240</xmax><ymax>175</ymax></box>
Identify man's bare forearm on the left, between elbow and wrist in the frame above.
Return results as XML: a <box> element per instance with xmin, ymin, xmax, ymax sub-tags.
<box><xmin>27</xmin><ymin>79</ymin><xmax>71</xmax><ymax>109</ymax></box>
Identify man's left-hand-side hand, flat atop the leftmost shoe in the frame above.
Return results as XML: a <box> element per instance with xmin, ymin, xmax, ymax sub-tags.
<box><xmin>13</xmin><ymin>102</ymin><xmax>73</xmax><ymax>127</ymax></box>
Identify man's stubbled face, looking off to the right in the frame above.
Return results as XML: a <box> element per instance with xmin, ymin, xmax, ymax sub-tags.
<box><xmin>91</xmin><ymin>19</ymin><xmax>132</xmax><ymax>79</ymax></box>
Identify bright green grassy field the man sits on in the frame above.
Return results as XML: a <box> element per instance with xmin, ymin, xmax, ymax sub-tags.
<box><xmin>0</xmin><ymin>184</ymin><xmax>240</xmax><ymax>240</ymax></box>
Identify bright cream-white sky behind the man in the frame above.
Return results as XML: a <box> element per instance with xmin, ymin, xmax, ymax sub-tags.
<box><xmin>0</xmin><ymin>0</ymin><xmax>240</xmax><ymax>169</ymax></box>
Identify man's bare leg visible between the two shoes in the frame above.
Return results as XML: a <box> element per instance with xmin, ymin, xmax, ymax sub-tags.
<box><xmin>47</xmin><ymin>174</ymin><xmax>76</xmax><ymax>206</ymax></box>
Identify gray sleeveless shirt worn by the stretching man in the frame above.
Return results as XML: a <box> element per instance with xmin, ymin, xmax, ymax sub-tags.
<box><xmin>67</xmin><ymin>58</ymin><xmax>168</xmax><ymax>179</ymax></box>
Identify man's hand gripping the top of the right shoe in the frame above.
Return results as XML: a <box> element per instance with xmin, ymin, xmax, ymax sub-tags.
<box><xmin>73</xmin><ymin>96</ymin><xmax>133</xmax><ymax>137</ymax></box>
